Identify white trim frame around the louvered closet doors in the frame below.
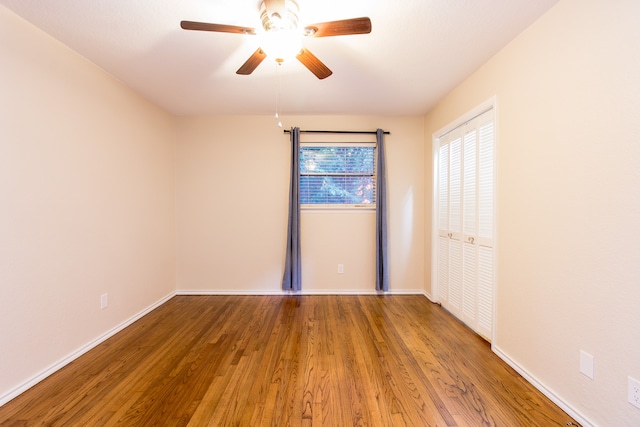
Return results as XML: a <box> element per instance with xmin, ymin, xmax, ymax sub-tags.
<box><xmin>431</xmin><ymin>96</ymin><xmax>498</xmax><ymax>342</ymax></box>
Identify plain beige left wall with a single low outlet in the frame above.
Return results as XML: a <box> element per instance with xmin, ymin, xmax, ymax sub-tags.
<box><xmin>0</xmin><ymin>6</ymin><xmax>175</xmax><ymax>400</ymax></box>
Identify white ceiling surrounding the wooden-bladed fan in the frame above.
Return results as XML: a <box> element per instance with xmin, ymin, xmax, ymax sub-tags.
<box><xmin>0</xmin><ymin>0</ymin><xmax>558</xmax><ymax>115</ymax></box>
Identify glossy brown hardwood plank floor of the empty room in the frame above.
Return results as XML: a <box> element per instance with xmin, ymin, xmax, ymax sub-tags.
<box><xmin>0</xmin><ymin>295</ymin><xmax>577</xmax><ymax>427</ymax></box>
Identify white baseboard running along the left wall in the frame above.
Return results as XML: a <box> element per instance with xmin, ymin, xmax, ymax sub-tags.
<box><xmin>0</xmin><ymin>292</ymin><xmax>176</xmax><ymax>406</ymax></box>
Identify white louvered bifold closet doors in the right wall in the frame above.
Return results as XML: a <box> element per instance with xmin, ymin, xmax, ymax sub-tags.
<box><xmin>437</xmin><ymin>110</ymin><xmax>494</xmax><ymax>338</ymax></box>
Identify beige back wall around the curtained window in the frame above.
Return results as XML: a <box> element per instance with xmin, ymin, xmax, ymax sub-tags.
<box><xmin>176</xmin><ymin>116</ymin><xmax>424</xmax><ymax>293</ymax></box>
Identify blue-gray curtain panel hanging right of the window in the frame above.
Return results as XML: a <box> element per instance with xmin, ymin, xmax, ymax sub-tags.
<box><xmin>376</xmin><ymin>129</ymin><xmax>389</xmax><ymax>291</ymax></box>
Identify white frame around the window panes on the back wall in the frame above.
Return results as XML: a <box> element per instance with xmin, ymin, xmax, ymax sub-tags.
<box><xmin>298</xmin><ymin>141</ymin><xmax>378</xmax><ymax>211</ymax></box>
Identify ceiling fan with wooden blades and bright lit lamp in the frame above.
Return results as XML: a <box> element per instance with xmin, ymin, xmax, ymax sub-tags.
<box><xmin>180</xmin><ymin>0</ymin><xmax>371</xmax><ymax>79</ymax></box>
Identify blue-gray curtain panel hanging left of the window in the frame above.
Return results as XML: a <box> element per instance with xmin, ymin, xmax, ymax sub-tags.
<box><xmin>282</xmin><ymin>127</ymin><xmax>302</xmax><ymax>291</ymax></box>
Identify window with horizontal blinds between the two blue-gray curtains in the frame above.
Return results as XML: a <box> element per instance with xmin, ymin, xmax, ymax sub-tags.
<box><xmin>300</xmin><ymin>143</ymin><xmax>376</xmax><ymax>208</ymax></box>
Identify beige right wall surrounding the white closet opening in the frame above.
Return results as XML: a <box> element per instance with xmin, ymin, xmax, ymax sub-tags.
<box><xmin>425</xmin><ymin>0</ymin><xmax>640</xmax><ymax>426</ymax></box>
